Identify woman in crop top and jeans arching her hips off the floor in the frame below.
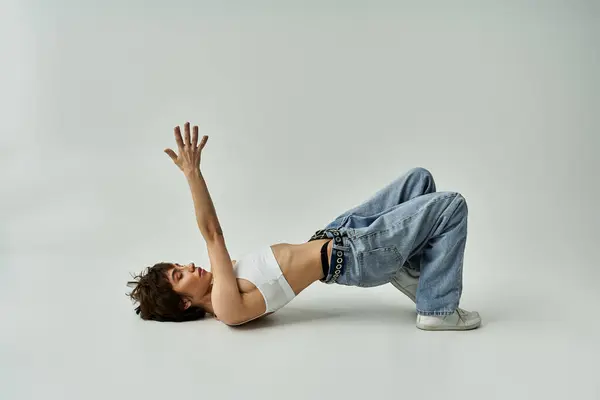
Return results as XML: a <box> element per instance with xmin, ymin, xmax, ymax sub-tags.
<box><xmin>129</xmin><ymin>122</ymin><xmax>481</xmax><ymax>330</ymax></box>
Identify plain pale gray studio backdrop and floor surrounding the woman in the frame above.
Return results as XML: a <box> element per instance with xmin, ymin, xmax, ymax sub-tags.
<box><xmin>0</xmin><ymin>1</ymin><xmax>600</xmax><ymax>399</ymax></box>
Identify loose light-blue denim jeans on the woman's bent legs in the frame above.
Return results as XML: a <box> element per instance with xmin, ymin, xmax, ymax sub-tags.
<box><xmin>318</xmin><ymin>168</ymin><xmax>468</xmax><ymax>315</ymax></box>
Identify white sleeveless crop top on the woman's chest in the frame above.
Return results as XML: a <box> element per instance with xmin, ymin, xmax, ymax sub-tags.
<box><xmin>233</xmin><ymin>246</ymin><xmax>296</xmax><ymax>318</ymax></box>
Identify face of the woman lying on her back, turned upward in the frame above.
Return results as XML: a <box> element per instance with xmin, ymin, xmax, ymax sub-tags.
<box><xmin>167</xmin><ymin>263</ymin><xmax>212</xmax><ymax>309</ymax></box>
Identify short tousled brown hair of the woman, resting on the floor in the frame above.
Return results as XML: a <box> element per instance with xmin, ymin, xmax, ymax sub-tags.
<box><xmin>127</xmin><ymin>262</ymin><xmax>206</xmax><ymax>322</ymax></box>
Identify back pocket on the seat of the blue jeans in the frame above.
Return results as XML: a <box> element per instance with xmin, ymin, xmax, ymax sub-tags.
<box><xmin>358</xmin><ymin>246</ymin><xmax>402</xmax><ymax>287</ymax></box>
